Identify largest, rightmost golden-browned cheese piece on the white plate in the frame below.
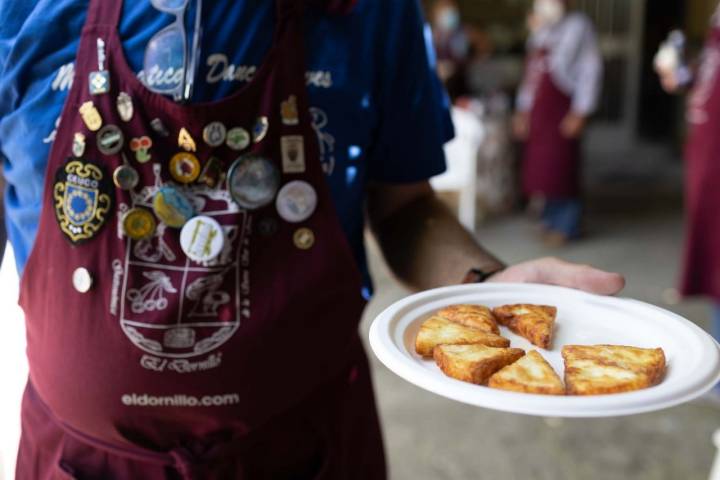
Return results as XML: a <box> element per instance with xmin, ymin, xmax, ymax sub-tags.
<box><xmin>562</xmin><ymin>345</ymin><xmax>665</xmax><ymax>395</ymax></box>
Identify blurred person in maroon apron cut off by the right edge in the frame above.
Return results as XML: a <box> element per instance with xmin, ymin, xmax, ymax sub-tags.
<box><xmin>655</xmin><ymin>6</ymin><xmax>720</xmax><ymax>368</ymax></box>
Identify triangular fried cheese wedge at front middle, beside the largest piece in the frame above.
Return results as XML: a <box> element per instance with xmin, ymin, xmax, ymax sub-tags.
<box><xmin>488</xmin><ymin>350</ymin><xmax>565</xmax><ymax>395</ymax></box>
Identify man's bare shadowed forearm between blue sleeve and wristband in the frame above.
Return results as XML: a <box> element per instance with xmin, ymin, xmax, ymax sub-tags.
<box><xmin>370</xmin><ymin>192</ymin><xmax>503</xmax><ymax>290</ymax></box>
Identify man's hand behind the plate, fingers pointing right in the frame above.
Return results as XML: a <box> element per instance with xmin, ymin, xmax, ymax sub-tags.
<box><xmin>487</xmin><ymin>258</ymin><xmax>625</xmax><ymax>295</ymax></box>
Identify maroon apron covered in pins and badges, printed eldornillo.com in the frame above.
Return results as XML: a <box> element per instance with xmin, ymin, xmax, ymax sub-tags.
<box><xmin>17</xmin><ymin>0</ymin><xmax>385</xmax><ymax>480</ymax></box>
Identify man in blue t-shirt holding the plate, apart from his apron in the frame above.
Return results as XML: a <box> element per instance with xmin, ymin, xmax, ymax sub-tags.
<box><xmin>0</xmin><ymin>0</ymin><xmax>624</xmax><ymax>476</ymax></box>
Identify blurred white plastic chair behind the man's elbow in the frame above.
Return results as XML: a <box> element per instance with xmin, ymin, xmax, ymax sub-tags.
<box><xmin>430</xmin><ymin>107</ymin><xmax>485</xmax><ymax>232</ymax></box>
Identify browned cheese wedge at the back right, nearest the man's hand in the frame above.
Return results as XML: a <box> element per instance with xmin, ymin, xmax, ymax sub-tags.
<box><xmin>493</xmin><ymin>304</ymin><xmax>557</xmax><ymax>349</ymax></box>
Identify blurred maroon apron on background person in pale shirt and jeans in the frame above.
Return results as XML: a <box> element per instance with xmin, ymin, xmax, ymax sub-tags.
<box><xmin>522</xmin><ymin>49</ymin><xmax>580</xmax><ymax>199</ymax></box>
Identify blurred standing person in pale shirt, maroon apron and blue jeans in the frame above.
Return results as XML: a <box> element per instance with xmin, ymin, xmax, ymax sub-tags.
<box><xmin>513</xmin><ymin>0</ymin><xmax>603</xmax><ymax>245</ymax></box>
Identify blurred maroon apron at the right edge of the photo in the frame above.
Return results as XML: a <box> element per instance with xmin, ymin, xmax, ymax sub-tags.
<box><xmin>681</xmin><ymin>27</ymin><xmax>720</xmax><ymax>300</ymax></box>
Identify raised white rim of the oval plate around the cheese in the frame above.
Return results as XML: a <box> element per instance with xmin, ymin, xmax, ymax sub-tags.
<box><xmin>368</xmin><ymin>282</ymin><xmax>720</xmax><ymax>418</ymax></box>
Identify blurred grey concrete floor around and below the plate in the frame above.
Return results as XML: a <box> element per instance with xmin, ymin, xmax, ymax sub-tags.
<box><xmin>364</xmin><ymin>181</ymin><xmax>720</xmax><ymax>480</ymax></box>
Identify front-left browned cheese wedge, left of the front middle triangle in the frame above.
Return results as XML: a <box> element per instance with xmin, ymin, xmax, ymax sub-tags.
<box><xmin>433</xmin><ymin>344</ymin><xmax>525</xmax><ymax>385</ymax></box>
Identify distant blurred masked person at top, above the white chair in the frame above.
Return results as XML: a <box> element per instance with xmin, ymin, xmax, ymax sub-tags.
<box><xmin>431</xmin><ymin>0</ymin><xmax>470</xmax><ymax>99</ymax></box>
